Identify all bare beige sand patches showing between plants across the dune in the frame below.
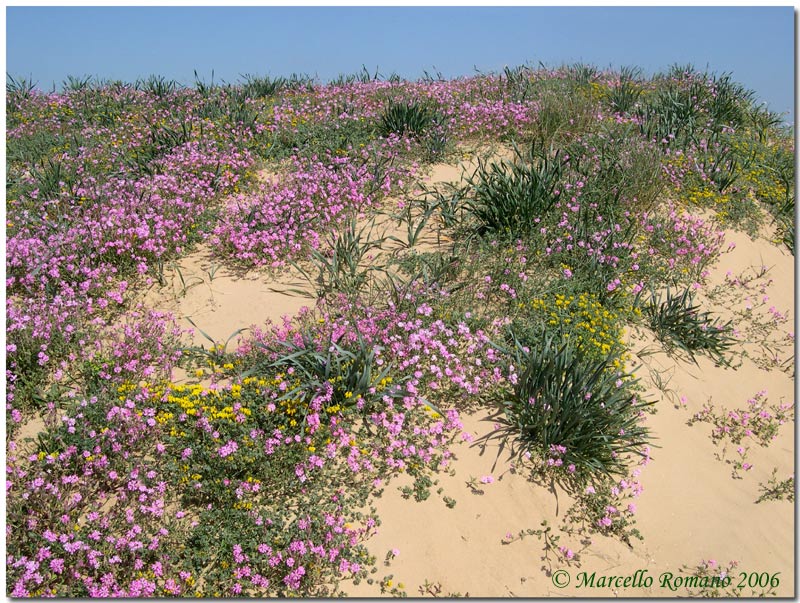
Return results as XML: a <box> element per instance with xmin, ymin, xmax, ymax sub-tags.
<box><xmin>15</xmin><ymin>147</ymin><xmax>794</xmax><ymax>597</ymax></box>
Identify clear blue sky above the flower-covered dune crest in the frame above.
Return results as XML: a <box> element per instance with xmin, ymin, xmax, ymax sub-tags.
<box><xmin>6</xmin><ymin>6</ymin><xmax>795</xmax><ymax>120</ymax></box>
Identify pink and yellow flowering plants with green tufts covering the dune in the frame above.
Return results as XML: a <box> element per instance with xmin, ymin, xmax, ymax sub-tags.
<box><xmin>5</xmin><ymin>65</ymin><xmax>795</xmax><ymax>597</ymax></box>
